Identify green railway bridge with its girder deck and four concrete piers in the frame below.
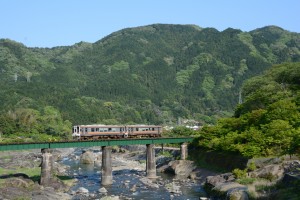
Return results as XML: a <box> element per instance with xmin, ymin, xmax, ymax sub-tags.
<box><xmin>0</xmin><ymin>137</ymin><xmax>193</xmax><ymax>185</ymax></box>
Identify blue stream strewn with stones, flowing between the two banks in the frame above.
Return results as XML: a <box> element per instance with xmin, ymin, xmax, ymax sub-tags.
<box><xmin>65</xmin><ymin>147</ymin><xmax>211</xmax><ymax>200</ymax></box>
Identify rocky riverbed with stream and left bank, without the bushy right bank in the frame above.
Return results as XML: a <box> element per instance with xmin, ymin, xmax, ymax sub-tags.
<box><xmin>0</xmin><ymin>147</ymin><xmax>212</xmax><ymax>200</ymax></box>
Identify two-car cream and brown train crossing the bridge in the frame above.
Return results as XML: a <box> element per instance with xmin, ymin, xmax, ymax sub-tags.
<box><xmin>72</xmin><ymin>124</ymin><xmax>162</xmax><ymax>140</ymax></box>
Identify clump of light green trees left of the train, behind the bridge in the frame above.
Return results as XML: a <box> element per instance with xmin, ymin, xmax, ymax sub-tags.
<box><xmin>0</xmin><ymin>106</ymin><xmax>72</xmax><ymax>143</ymax></box>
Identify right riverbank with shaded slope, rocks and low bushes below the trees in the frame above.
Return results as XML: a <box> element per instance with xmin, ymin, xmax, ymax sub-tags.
<box><xmin>190</xmin><ymin>149</ymin><xmax>300</xmax><ymax>200</ymax></box>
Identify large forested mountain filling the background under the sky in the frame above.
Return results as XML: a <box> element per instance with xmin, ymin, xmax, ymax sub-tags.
<box><xmin>0</xmin><ymin>24</ymin><xmax>300</xmax><ymax>136</ymax></box>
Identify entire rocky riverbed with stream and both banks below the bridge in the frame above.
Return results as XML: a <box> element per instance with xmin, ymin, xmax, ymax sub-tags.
<box><xmin>0</xmin><ymin>146</ymin><xmax>300</xmax><ymax>200</ymax></box>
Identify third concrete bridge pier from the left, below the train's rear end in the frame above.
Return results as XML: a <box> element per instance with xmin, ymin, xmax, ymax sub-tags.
<box><xmin>146</xmin><ymin>144</ymin><xmax>157</xmax><ymax>178</ymax></box>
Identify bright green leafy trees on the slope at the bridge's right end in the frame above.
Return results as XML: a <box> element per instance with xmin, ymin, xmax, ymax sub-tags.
<box><xmin>194</xmin><ymin>62</ymin><xmax>300</xmax><ymax>157</ymax></box>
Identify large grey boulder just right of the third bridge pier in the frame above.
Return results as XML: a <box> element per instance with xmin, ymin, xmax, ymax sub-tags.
<box><xmin>165</xmin><ymin>160</ymin><xmax>196</xmax><ymax>177</ymax></box>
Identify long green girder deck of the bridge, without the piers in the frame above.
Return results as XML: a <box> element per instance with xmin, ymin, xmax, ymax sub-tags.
<box><xmin>0</xmin><ymin>137</ymin><xmax>193</xmax><ymax>151</ymax></box>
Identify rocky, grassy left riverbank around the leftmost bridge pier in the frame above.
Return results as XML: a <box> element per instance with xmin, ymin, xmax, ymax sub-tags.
<box><xmin>0</xmin><ymin>150</ymin><xmax>74</xmax><ymax>200</ymax></box>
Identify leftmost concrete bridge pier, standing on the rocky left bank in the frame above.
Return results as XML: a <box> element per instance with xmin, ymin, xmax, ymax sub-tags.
<box><xmin>40</xmin><ymin>149</ymin><xmax>53</xmax><ymax>186</ymax></box>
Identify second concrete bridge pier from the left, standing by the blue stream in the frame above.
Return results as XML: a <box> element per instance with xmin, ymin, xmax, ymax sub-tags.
<box><xmin>101</xmin><ymin>146</ymin><xmax>112</xmax><ymax>185</ymax></box>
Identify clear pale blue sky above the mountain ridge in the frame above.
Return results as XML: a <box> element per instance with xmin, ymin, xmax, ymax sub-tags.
<box><xmin>0</xmin><ymin>0</ymin><xmax>300</xmax><ymax>47</ymax></box>
